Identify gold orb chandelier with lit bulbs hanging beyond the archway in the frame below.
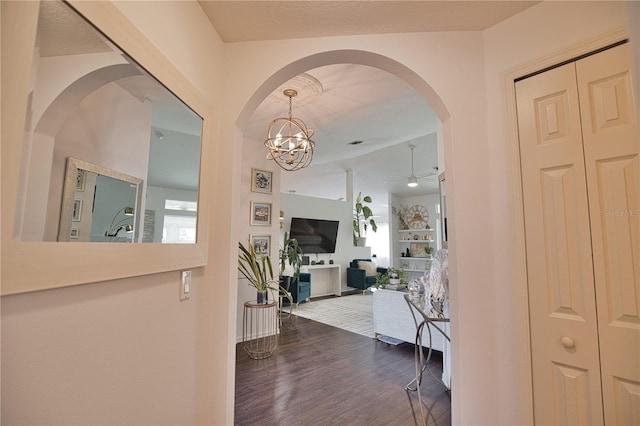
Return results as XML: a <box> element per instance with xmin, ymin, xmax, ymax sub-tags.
<box><xmin>264</xmin><ymin>89</ymin><xmax>315</xmax><ymax>172</ymax></box>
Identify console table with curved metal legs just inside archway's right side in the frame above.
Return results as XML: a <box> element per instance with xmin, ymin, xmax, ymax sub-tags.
<box><xmin>404</xmin><ymin>294</ymin><xmax>451</xmax><ymax>425</ymax></box>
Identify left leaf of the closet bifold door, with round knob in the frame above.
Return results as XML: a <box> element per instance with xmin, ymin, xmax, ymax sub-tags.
<box><xmin>516</xmin><ymin>64</ymin><xmax>603</xmax><ymax>425</ymax></box>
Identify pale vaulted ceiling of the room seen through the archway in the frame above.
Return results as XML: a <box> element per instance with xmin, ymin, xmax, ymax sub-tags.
<box><xmin>245</xmin><ymin>64</ymin><xmax>438</xmax><ymax>205</ymax></box>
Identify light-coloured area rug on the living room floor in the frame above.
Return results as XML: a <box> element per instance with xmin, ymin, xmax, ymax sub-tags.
<box><xmin>293</xmin><ymin>293</ymin><xmax>374</xmax><ymax>337</ymax></box>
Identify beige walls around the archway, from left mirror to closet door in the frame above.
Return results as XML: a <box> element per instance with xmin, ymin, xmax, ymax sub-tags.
<box><xmin>2</xmin><ymin>2</ymin><xmax>626</xmax><ymax>424</ymax></box>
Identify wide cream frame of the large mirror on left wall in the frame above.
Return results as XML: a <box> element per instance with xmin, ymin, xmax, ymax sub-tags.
<box><xmin>0</xmin><ymin>0</ymin><xmax>213</xmax><ymax>296</ymax></box>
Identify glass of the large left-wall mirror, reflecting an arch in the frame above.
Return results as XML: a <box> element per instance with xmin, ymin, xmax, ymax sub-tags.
<box><xmin>16</xmin><ymin>1</ymin><xmax>202</xmax><ymax>243</ymax></box>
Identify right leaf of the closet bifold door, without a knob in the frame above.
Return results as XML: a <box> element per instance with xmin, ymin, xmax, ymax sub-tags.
<box><xmin>576</xmin><ymin>44</ymin><xmax>640</xmax><ymax>424</ymax></box>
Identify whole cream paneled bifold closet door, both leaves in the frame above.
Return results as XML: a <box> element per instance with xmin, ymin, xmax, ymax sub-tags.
<box><xmin>516</xmin><ymin>44</ymin><xmax>640</xmax><ymax>425</ymax></box>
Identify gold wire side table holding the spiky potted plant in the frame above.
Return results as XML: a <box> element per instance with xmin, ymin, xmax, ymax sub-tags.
<box><xmin>242</xmin><ymin>301</ymin><xmax>278</xmax><ymax>359</ymax></box>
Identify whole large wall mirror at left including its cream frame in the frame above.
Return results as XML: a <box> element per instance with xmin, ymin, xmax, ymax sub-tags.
<box><xmin>1</xmin><ymin>0</ymin><xmax>212</xmax><ymax>295</ymax></box>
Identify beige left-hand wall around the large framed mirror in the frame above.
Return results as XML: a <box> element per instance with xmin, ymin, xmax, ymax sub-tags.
<box><xmin>1</xmin><ymin>2</ymin><xmax>230</xmax><ymax>425</ymax></box>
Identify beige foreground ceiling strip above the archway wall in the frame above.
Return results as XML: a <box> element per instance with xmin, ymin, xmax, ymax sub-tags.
<box><xmin>200</xmin><ymin>0</ymin><xmax>538</xmax><ymax>42</ymax></box>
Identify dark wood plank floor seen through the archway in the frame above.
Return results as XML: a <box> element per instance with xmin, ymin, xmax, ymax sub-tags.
<box><xmin>235</xmin><ymin>316</ymin><xmax>451</xmax><ymax>426</ymax></box>
